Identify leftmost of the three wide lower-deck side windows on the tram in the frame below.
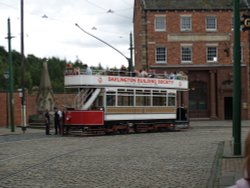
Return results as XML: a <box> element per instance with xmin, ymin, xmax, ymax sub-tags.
<box><xmin>117</xmin><ymin>90</ymin><xmax>134</xmax><ymax>106</ymax></box>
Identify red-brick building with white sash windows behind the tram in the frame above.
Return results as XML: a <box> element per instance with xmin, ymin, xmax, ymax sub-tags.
<box><xmin>134</xmin><ymin>0</ymin><xmax>250</xmax><ymax>120</ymax></box>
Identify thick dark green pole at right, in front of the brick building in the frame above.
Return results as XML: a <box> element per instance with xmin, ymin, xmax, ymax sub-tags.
<box><xmin>233</xmin><ymin>0</ymin><xmax>241</xmax><ymax>155</ymax></box>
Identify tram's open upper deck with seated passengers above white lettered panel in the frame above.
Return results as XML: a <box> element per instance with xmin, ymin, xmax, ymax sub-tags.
<box><xmin>64</xmin><ymin>70</ymin><xmax>188</xmax><ymax>90</ymax></box>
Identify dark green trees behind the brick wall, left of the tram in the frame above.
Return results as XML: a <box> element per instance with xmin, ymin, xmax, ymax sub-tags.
<box><xmin>0</xmin><ymin>46</ymin><xmax>116</xmax><ymax>93</ymax></box>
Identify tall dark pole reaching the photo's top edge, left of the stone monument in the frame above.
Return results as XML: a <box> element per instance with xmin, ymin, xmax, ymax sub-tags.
<box><xmin>21</xmin><ymin>0</ymin><xmax>26</xmax><ymax>133</ymax></box>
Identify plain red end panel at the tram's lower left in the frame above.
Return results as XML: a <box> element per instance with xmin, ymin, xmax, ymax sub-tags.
<box><xmin>64</xmin><ymin>111</ymin><xmax>104</xmax><ymax>126</ymax></box>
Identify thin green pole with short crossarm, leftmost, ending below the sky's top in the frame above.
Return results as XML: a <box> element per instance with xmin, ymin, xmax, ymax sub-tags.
<box><xmin>7</xmin><ymin>18</ymin><xmax>15</xmax><ymax>132</ymax></box>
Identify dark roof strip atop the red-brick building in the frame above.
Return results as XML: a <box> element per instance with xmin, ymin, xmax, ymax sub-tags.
<box><xmin>142</xmin><ymin>0</ymin><xmax>250</xmax><ymax>10</ymax></box>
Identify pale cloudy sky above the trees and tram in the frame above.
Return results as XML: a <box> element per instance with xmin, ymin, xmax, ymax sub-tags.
<box><xmin>0</xmin><ymin>0</ymin><xmax>134</xmax><ymax>68</ymax></box>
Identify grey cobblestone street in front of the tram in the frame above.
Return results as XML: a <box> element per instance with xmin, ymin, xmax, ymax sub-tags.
<box><xmin>0</xmin><ymin>122</ymin><xmax>248</xmax><ymax>188</ymax></box>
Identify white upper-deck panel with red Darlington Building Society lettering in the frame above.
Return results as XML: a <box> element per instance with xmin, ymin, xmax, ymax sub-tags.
<box><xmin>64</xmin><ymin>74</ymin><xmax>188</xmax><ymax>90</ymax></box>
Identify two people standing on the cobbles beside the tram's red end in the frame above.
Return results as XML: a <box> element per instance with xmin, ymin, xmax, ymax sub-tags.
<box><xmin>44</xmin><ymin>107</ymin><xmax>63</xmax><ymax>135</ymax></box>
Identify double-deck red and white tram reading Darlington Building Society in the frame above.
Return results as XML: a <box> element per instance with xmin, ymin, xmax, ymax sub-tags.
<box><xmin>63</xmin><ymin>71</ymin><xmax>189</xmax><ymax>134</ymax></box>
